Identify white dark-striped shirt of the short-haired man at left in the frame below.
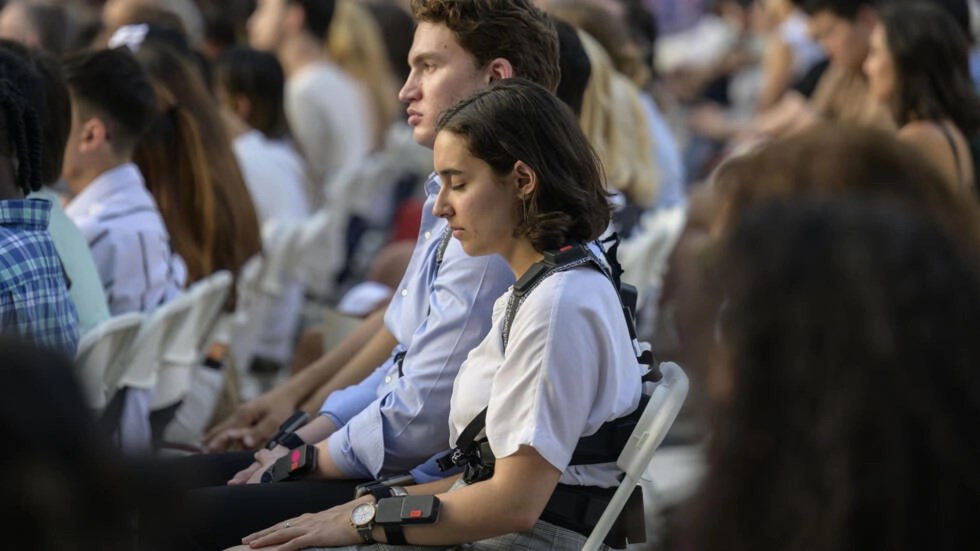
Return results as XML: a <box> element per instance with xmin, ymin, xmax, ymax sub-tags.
<box><xmin>65</xmin><ymin>163</ymin><xmax>187</xmax><ymax>315</ymax></box>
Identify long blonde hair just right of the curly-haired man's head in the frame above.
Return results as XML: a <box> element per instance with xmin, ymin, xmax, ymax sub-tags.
<box><xmin>579</xmin><ymin>30</ymin><xmax>660</xmax><ymax>207</ymax></box>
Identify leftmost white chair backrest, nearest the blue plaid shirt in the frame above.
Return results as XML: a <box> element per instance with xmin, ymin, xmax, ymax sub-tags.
<box><xmin>75</xmin><ymin>312</ymin><xmax>143</xmax><ymax>410</ymax></box>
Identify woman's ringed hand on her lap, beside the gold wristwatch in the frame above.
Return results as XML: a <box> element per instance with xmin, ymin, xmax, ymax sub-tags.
<box><xmin>235</xmin><ymin>496</ymin><xmax>366</xmax><ymax>551</ymax></box>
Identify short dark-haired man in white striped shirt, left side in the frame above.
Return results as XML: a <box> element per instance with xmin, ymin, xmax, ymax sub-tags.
<box><xmin>62</xmin><ymin>50</ymin><xmax>187</xmax><ymax>315</ymax></box>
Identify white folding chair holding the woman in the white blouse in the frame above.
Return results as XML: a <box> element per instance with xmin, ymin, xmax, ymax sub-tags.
<box><xmin>582</xmin><ymin>362</ymin><xmax>688</xmax><ymax>551</ymax></box>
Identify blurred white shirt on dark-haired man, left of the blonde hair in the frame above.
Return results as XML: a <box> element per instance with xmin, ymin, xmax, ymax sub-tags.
<box><xmin>285</xmin><ymin>61</ymin><xmax>374</xmax><ymax>206</ymax></box>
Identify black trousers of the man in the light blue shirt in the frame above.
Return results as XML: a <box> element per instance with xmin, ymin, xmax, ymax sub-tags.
<box><xmin>144</xmin><ymin>452</ymin><xmax>364</xmax><ymax>551</ymax></box>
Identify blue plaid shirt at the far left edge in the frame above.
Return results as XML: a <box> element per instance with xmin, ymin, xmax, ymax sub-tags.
<box><xmin>0</xmin><ymin>199</ymin><xmax>78</xmax><ymax>356</ymax></box>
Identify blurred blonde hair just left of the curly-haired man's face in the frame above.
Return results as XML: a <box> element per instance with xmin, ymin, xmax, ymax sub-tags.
<box><xmin>326</xmin><ymin>0</ymin><xmax>401</xmax><ymax>149</ymax></box>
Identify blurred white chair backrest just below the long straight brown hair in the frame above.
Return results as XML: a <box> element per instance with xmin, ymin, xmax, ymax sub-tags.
<box><xmin>150</xmin><ymin>271</ymin><xmax>232</xmax><ymax>411</ymax></box>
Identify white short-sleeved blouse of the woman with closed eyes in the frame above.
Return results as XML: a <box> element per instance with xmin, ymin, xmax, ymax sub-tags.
<box><xmin>449</xmin><ymin>265</ymin><xmax>642</xmax><ymax>487</ymax></box>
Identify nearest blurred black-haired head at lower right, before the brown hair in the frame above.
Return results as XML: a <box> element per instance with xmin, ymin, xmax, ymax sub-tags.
<box><xmin>674</xmin><ymin>192</ymin><xmax>980</xmax><ymax>551</ymax></box>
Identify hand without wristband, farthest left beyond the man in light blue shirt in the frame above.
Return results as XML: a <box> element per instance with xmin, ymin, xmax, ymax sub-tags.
<box><xmin>204</xmin><ymin>389</ymin><xmax>296</xmax><ymax>452</ymax></box>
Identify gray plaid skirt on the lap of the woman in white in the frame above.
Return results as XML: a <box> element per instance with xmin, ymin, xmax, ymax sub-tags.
<box><xmin>305</xmin><ymin>520</ymin><xmax>605</xmax><ymax>551</ymax></box>
